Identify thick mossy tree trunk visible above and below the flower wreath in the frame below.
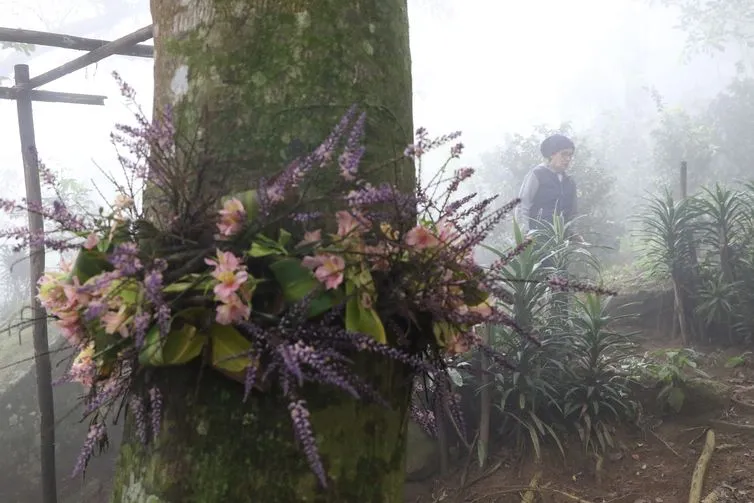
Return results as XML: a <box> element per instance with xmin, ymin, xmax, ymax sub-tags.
<box><xmin>113</xmin><ymin>0</ymin><xmax>414</xmax><ymax>503</ymax></box>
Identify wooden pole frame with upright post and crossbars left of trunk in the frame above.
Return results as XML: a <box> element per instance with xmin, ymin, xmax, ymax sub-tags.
<box><xmin>0</xmin><ymin>25</ymin><xmax>154</xmax><ymax>503</ymax></box>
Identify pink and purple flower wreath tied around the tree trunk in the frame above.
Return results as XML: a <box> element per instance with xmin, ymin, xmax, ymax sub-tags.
<box><xmin>2</xmin><ymin>77</ymin><xmax>544</xmax><ymax>485</ymax></box>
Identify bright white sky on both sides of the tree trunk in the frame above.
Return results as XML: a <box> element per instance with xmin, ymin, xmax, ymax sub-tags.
<box><xmin>0</xmin><ymin>0</ymin><xmax>732</xmax><ymax>209</ymax></box>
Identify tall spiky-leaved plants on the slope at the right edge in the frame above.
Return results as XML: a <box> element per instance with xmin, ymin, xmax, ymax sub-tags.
<box><xmin>641</xmin><ymin>183</ymin><xmax>754</xmax><ymax>343</ymax></box>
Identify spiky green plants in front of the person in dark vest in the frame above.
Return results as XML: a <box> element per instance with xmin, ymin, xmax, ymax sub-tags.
<box><xmin>438</xmin><ymin>220</ymin><xmax>635</xmax><ymax>458</ymax></box>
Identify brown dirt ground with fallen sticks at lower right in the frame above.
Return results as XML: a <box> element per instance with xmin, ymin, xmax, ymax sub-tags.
<box><xmin>405</xmin><ymin>338</ymin><xmax>754</xmax><ymax>503</ymax></box>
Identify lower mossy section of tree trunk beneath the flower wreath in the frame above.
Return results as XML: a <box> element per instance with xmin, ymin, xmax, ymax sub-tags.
<box><xmin>113</xmin><ymin>361</ymin><xmax>408</xmax><ymax>503</ymax></box>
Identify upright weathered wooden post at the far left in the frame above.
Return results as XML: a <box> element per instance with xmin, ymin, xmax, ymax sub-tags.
<box><xmin>14</xmin><ymin>65</ymin><xmax>57</xmax><ymax>503</ymax></box>
